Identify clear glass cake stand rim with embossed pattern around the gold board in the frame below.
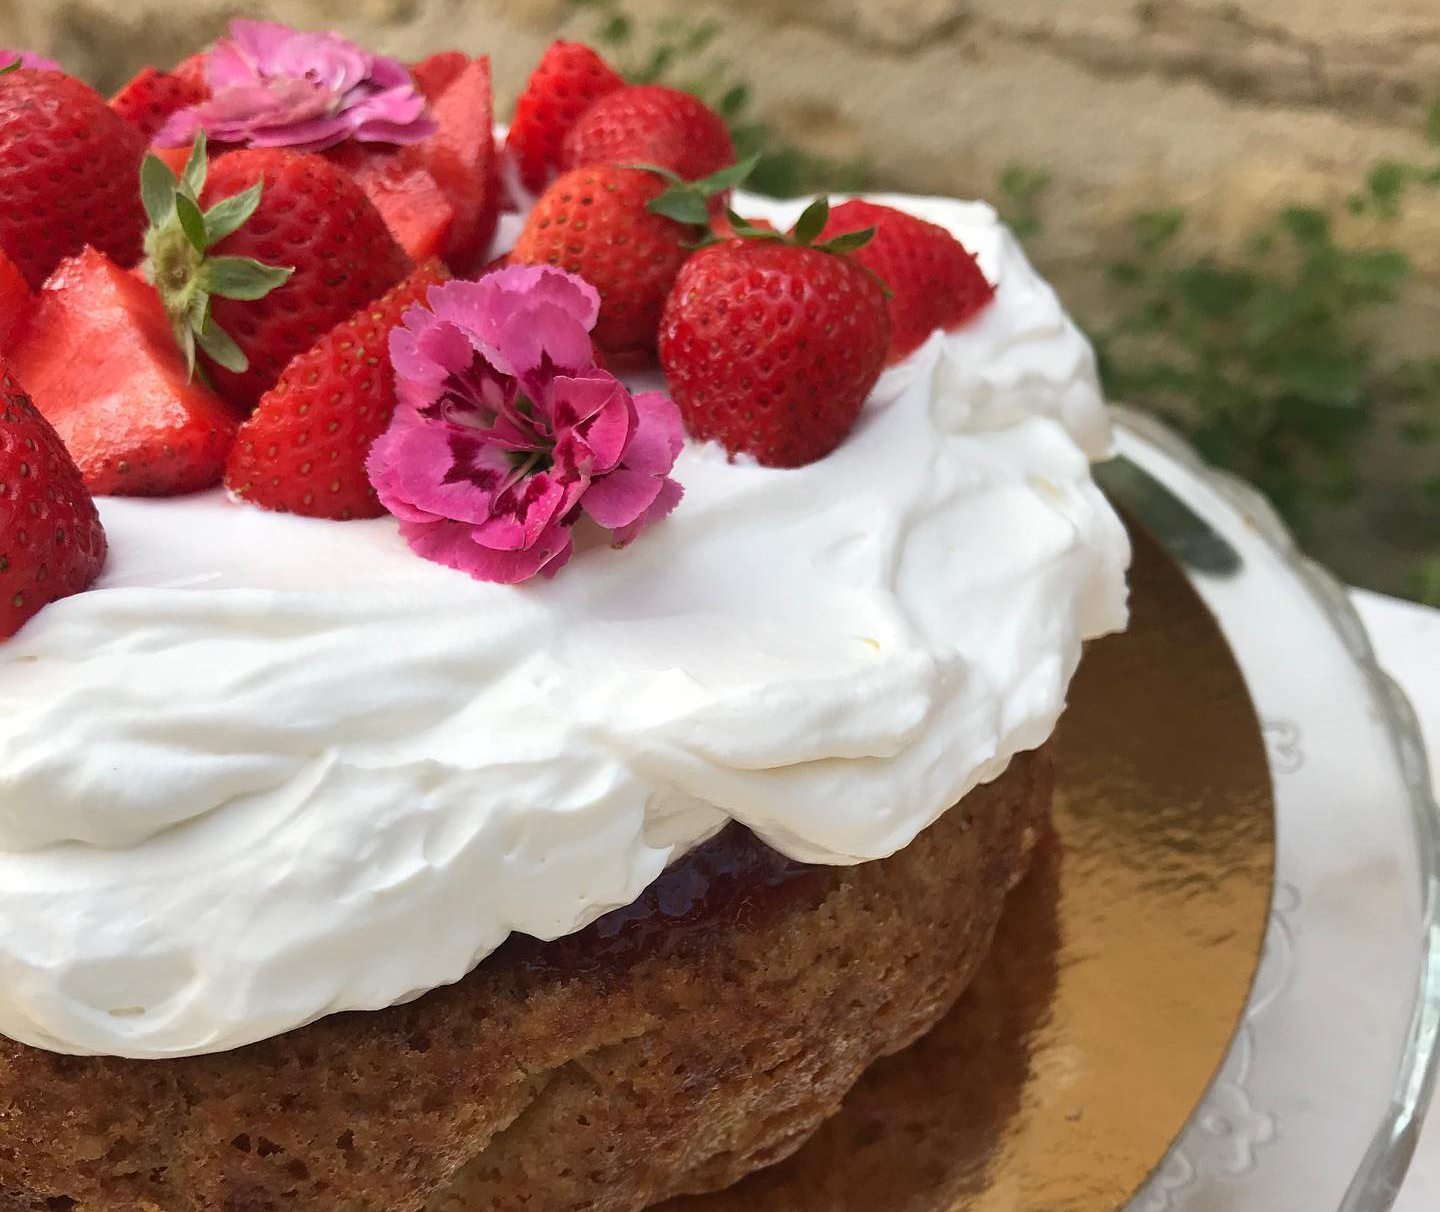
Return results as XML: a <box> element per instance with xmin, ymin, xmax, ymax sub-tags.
<box><xmin>1100</xmin><ymin>409</ymin><xmax>1440</xmax><ymax>1212</ymax></box>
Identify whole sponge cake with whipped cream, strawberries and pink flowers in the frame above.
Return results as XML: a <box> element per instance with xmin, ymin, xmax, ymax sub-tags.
<box><xmin>0</xmin><ymin>23</ymin><xmax>1129</xmax><ymax>1212</ymax></box>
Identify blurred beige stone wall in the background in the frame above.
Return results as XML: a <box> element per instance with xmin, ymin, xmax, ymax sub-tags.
<box><xmin>0</xmin><ymin>0</ymin><xmax>1440</xmax><ymax>587</ymax></box>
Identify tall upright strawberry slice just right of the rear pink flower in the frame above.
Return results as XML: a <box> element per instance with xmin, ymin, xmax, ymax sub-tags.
<box><xmin>422</xmin><ymin>56</ymin><xmax>500</xmax><ymax>273</ymax></box>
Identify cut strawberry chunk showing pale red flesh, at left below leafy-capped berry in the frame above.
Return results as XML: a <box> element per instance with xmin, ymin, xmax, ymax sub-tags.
<box><xmin>12</xmin><ymin>249</ymin><xmax>235</xmax><ymax>497</ymax></box>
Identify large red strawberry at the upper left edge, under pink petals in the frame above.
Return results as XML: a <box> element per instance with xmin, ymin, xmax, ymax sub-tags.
<box><xmin>0</xmin><ymin>68</ymin><xmax>145</xmax><ymax>288</ymax></box>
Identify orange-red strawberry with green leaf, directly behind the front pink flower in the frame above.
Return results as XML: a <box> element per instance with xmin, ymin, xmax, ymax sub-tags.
<box><xmin>510</xmin><ymin>164</ymin><xmax>750</xmax><ymax>353</ymax></box>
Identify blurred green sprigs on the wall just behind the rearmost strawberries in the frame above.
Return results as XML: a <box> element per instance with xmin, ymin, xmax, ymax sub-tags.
<box><xmin>570</xmin><ymin>0</ymin><xmax>870</xmax><ymax>197</ymax></box>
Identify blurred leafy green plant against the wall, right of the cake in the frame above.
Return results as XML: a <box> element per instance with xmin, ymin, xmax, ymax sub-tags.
<box><xmin>998</xmin><ymin>127</ymin><xmax>1440</xmax><ymax>605</ymax></box>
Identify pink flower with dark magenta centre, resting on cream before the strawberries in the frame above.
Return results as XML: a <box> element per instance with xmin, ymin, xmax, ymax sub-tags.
<box><xmin>367</xmin><ymin>266</ymin><xmax>684</xmax><ymax>583</ymax></box>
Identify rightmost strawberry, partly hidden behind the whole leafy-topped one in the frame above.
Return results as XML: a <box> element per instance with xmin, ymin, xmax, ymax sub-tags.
<box><xmin>821</xmin><ymin>200</ymin><xmax>995</xmax><ymax>363</ymax></box>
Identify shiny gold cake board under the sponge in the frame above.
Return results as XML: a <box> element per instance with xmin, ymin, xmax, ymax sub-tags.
<box><xmin>662</xmin><ymin>528</ymin><xmax>1274</xmax><ymax>1212</ymax></box>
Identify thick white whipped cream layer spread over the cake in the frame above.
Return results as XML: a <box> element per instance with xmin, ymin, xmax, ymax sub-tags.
<box><xmin>0</xmin><ymin>197</ymin><xmax>1129</xmax><ymax>1058</ymax></box>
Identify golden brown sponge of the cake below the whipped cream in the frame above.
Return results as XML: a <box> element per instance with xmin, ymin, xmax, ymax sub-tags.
<box><xmin>0</xmin><ymin>751</ymin><xmax>1051</xmax><ymax>1212</ymax></box>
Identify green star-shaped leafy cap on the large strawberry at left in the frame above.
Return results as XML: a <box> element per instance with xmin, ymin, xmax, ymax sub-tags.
<box><xmin>140</xmin><ymin>131</ymin><xmax>295</xmax><ymax>374</ymax></box>
